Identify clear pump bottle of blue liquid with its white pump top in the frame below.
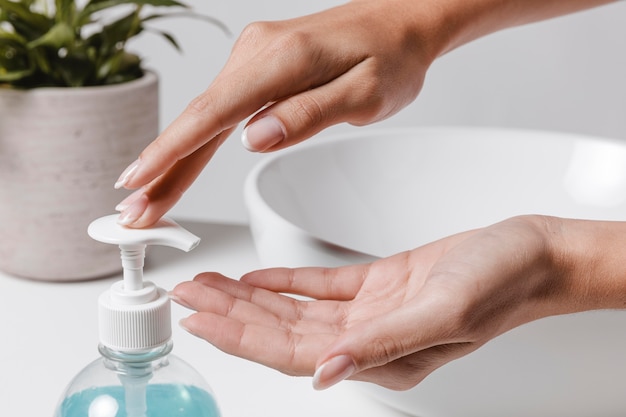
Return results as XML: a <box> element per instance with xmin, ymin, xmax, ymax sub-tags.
<box><xmin>54</xmin><ymin>215</ymin><xmax>220</xmax><ymax>417</ymax></box>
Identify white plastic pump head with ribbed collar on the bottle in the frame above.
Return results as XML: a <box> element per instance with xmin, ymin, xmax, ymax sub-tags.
<box><xmin>88</xmin><ymin>214</ymin><xmax>200</xmax><ymax>351</ymax></box>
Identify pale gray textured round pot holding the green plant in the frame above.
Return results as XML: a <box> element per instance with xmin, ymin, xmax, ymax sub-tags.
<box><xmin>0</xmin><ymin>72</ymin><xmax>159</xmax><ymax>281</ymax></box>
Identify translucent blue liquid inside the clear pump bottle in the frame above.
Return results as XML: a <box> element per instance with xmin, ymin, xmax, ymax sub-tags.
<box><xmin>59</xmin><ymin>384</ymin><xmax>220</xmax><ymax>417</ymax></box>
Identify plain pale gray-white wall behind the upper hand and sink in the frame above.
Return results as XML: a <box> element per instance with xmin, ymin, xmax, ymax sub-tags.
<box><xmin>131</xmin><ymin>0</ymin><xmax>626</xmax><ymax>223</ymax></box>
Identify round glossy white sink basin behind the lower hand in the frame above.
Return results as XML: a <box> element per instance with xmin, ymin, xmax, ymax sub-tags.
<box><xmin>245</xmin><ymin>128</ymin><xmax>626</xmax><ymax>417</ymax></box>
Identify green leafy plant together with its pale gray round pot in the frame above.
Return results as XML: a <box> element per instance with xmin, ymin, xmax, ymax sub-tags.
<box><xmin>0</xmin><ymin>0</ymin><xmax>225</xmax><ymax>281</ymax></box>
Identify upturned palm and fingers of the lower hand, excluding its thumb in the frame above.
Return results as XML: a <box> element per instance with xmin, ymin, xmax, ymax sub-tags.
<box><xmin>174</xmin><ymin>229</ymin><xmax>468</xmax><ymax>375</ymax></box>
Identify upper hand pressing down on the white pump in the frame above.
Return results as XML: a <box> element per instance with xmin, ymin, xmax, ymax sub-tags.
<box><xmin>116</xmin><ymin>0</ymin><xmax>440</xmax><ymax>227</ymax></box>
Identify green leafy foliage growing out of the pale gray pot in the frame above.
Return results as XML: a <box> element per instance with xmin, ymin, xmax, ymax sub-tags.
<box><xmin>0</xmin><ymin>0</ymin><xmax>228</xmax><ymax>88</ymax></box>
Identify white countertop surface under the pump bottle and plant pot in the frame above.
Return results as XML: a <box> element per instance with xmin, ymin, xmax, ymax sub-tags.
<box><xmin>0</xmin><ymin>222</ymin><xmax>403</xmax><ymax>417</ymax></box>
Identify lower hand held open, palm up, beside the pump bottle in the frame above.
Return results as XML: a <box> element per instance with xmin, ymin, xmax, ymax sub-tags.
<box><xmin>172</xmin><ymin>216</ymin><xmax>601</xmax><ymax>389</ymax></box>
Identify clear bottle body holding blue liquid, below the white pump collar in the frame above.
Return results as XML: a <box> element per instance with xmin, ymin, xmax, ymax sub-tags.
<box><xmin>54</xmin><ymin>342</ymin><xmax>220</xmax><ymax>417</ymax></box>
